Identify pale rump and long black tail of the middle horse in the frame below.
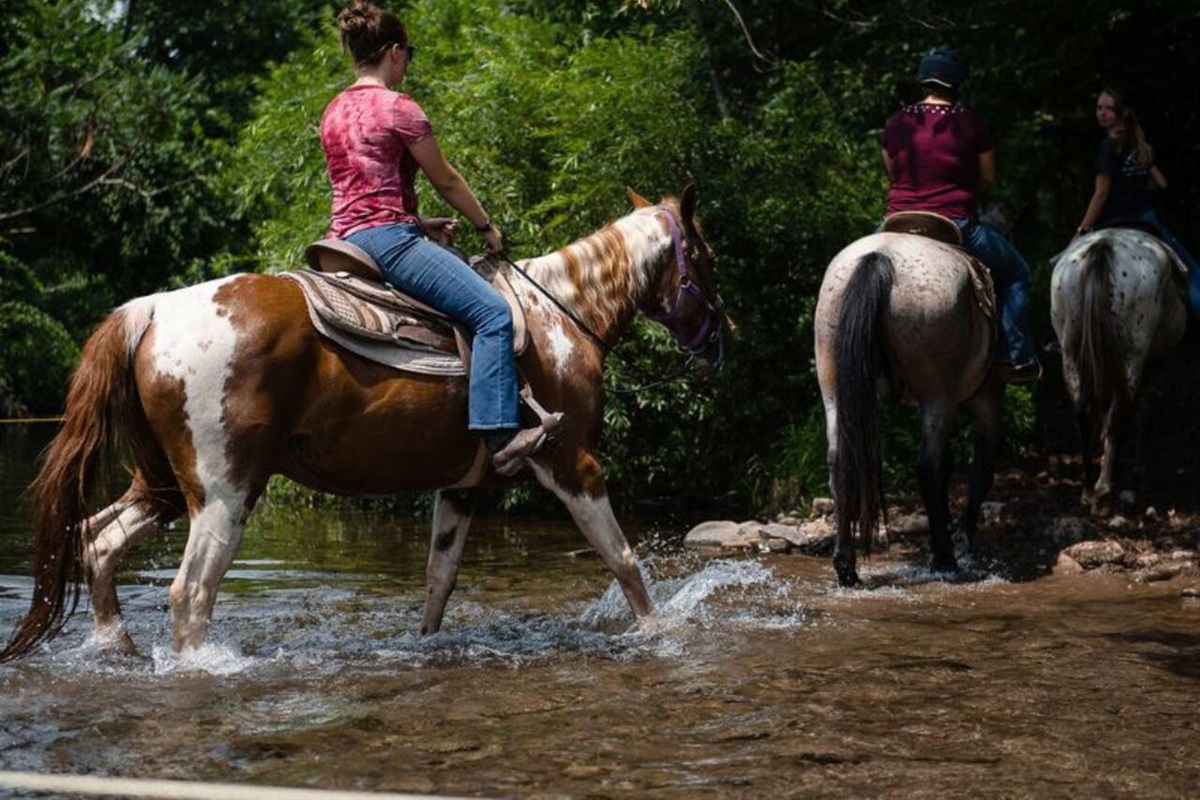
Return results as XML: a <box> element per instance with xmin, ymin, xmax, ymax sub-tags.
<box><xmin>815</xmin><ymin>233</ymin><xmax>995</xmax><ymax>568</ymax></box>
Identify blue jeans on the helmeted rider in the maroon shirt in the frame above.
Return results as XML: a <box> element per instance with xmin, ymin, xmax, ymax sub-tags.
<box><xmin>954</xmin><ymin>219</ymin><xmax>1037</xmax><ymax>363</ymax></box>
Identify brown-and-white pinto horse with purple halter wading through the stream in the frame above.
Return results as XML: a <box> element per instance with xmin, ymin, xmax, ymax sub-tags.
<box><xmin>0</xmin><ymin>186</ymin><xmax>732</xmax><ymax>661</ymax></box>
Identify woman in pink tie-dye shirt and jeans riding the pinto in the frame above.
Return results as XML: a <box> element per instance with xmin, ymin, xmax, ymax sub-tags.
<box><xmin>320</xmin><ymin>0</ymin><xmax>557</xmax><ymax>474</ymax></box>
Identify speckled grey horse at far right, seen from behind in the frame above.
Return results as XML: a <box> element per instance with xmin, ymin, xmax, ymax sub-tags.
<box><xmin>1050</xmin><ymin>228</ymin><xmax>1187</xmax><ymax>513</ymax></box>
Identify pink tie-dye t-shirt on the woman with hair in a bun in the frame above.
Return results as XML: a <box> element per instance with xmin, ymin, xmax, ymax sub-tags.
<box><xmin>320</xmin><ymin>85</ymin><xmax>433</xmax><ymax>239</ymax></box>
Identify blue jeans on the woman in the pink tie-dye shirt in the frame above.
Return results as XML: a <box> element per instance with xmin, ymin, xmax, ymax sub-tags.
<box><xmin>347</xmin><ymin>224</ymin><xmax>520</xmax><ymax>431</ymax></box>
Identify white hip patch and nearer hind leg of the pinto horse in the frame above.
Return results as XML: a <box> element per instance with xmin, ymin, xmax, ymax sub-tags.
<box><xmin>154</xmin><ymin>277</ymin><xmax>248</xmax><ymax>649</ymax></box>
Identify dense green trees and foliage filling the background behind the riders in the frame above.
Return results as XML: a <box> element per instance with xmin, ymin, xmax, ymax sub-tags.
<box><xmin>0</xmin><ymin>0</ymin><xmax>1200</xmax><ymax>520</ymax></box>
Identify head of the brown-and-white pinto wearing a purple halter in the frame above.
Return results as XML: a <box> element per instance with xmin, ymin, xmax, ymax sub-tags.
<box><xmin>625</xmin><ymin>184</ymin><xmax>737</xmax><ymax>369</ymax></box>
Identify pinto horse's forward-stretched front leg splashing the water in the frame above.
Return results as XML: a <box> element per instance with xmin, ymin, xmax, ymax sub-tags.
<box><xmin>530</xmin><ymin>451</ymin><xmax>654</xmax><ymax>619</ymax></box>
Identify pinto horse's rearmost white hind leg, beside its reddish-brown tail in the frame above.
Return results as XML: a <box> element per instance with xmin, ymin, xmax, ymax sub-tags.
<box><xmin>83</xmin><ymin>503</ymin><xmax>158</xmax><ymax>652</ymax></box>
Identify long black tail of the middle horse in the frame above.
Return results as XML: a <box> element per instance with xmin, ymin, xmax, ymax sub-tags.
<box><xmin>833</xmin><ymin>252</ymin><xmax>895</xmax><ymax>551</ymax></box>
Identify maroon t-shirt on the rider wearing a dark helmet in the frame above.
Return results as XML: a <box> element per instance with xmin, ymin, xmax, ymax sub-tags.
<box><xmin>883</xmin><ymin>103</ymin><xmax>992</xmax><ymax>219</ymax></box>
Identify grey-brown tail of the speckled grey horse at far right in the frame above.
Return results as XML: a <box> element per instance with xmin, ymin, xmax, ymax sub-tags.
<box><xmin>1076</xmin><ymin>240</ymin><xmax>1129</xmax><ymax>434</ymax></box>
